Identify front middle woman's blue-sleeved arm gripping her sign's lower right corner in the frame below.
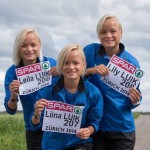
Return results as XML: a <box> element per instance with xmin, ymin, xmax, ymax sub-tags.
<box><xmin>76</xmin><ymin>85</ymin><xmax>103</xmax><ymax>139</ymax></box>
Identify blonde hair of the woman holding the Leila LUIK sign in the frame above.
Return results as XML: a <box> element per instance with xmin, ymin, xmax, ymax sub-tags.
<box><xmin>12</xmin><ymin>28</ymin><xmax>43</xmax><ymax>66</ymax></box>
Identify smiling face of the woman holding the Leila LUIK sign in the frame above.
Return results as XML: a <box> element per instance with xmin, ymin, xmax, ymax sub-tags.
<box><xmin>20</xmin><ymin>33</ymin><xmax>41</xmax><ymax>65</ymax></box>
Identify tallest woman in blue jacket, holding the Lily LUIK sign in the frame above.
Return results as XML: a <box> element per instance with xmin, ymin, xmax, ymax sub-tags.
<box><xmin>84</xmin><ymin>15</ymin><xmax>141</xmax><ymax>150</ymax></box>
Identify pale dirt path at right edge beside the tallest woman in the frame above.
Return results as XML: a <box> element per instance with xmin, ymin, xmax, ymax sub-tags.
<box><xmin>134</xmin><ymin>115</ymin><xmax>150</xmax><ymax>150</ymax></box>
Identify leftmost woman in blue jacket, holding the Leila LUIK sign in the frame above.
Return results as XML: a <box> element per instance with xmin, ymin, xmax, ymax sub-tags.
<box><xmin>4</xmin><ymin>28</ymin><xmax>56</xmax><ymax>150</ymax></box>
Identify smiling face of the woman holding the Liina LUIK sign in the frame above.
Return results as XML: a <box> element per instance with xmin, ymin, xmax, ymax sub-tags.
<box><xmin>62</xmin><ymin>50</ymin><xmax>85</xmax><ymax>81</ymax></box>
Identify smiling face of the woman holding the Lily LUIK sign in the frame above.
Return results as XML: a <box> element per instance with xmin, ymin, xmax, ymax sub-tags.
<box><xmin>100</xmin><ymin>18</ymin><xmax>122</xmax><ymax>49</ymax></box>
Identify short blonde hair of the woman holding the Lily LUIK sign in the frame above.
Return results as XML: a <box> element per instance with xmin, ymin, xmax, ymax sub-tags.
<box><xmin>96</xmin><ymin>14</ymin><xmax>122</xmax><ymax>38</ymax></box>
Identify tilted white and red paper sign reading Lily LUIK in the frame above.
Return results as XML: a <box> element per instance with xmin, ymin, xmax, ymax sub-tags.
<box><xmin>101</xmin><ymin>55</ymin><xmax>144</xmax><ymax>97</ymax></box>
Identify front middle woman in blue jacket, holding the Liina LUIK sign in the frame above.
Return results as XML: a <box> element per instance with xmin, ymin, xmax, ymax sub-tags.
<box><xmin>31</xmin><ymin>44</ymin><xmax>103</xmax><ymax>150</ymax></box>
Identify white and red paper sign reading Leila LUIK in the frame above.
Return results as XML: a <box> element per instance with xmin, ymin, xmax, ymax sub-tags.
<box><xmin>16</xmin><ymin>61</ymin><xmax>52</xmax><ymax>95</ymax></box>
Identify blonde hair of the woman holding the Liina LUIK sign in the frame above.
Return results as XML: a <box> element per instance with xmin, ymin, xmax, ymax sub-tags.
<box><xmin>57</xmin><ymin>44</ymin><xmax>86</xmax><ymax>76</ymax></box>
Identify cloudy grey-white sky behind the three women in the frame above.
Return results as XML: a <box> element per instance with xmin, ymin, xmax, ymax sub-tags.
<box><xmin>0</xmin><ymin>0</ymin><xmax>150</xmax><ymax>112</ymax></box>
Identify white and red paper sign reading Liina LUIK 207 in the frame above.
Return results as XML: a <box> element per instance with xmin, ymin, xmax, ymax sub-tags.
<box><xmin>42</xmin><ymin>101</ymin><xmax>83</xmax><ymax>134</ymax></box>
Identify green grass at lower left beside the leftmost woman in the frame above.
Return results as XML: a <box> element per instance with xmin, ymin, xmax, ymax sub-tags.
<box><xmin>0</xmin><ymin>113</ymin><xmax>26</xmax><ymax>150</ymax></box>
